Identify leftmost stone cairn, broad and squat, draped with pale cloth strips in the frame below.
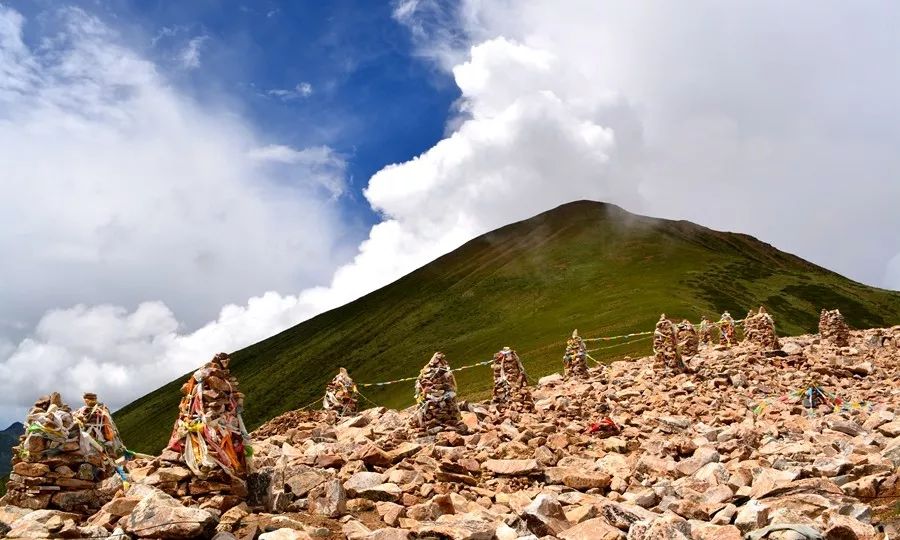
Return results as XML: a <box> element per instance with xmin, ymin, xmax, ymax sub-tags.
<box><xmin>0</xmin><ymin>392</ymin><xmax>117</xmax><ymax>514</ymax></box>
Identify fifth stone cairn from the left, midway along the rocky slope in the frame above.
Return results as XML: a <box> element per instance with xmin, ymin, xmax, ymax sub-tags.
<box><xmin>411</xmin><ymin>352</ymin><xmax>465</xmax><ymax>433</ymax></box>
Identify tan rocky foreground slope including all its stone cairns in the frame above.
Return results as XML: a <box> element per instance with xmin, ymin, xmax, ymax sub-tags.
<box><xmin>7</xmin><ymin>308</ymin><xmax>900</xmax><ymax>540</ymax></box>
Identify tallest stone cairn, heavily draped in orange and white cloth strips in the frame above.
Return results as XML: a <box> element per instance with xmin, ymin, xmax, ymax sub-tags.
<box><xmin>157</xmin><ymin>353</ymin><xmax>252</xmax><ymax>499</ymax></box>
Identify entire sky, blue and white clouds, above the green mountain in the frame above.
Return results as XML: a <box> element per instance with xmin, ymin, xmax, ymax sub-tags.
<box><xmin>0</xmin><ymin>0</ymin><xmax>900</xmax><ymax>423</ymax></box>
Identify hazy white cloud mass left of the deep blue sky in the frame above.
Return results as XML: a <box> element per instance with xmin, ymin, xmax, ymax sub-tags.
<box><xmin>0</xmin><ymin>7</ymin><xmax>347</xmax><ymax>420</ymax></box>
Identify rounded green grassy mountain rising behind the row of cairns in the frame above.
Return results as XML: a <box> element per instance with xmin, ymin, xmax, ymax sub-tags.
<box><xmin>115</xmin><ymin>201</ymin><xmax>900</xmax><ymax>452</ymax></box>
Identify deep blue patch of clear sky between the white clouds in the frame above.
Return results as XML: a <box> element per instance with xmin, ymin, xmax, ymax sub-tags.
<box><xmin>10</xmin><ymin>0</ymin><xmax>460</xmax><ymax>226</ymax></box>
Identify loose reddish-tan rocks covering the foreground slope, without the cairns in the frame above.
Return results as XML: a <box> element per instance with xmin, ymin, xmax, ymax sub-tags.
<box><xmin>0</xmin><ymin>326</ymin><xmax>900</xmax><ymax>540</ymax></box>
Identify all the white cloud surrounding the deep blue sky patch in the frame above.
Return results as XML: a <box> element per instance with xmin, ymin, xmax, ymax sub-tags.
<box><xmin>0</xmin><ymin>0</ymin><xmax>900</xmax><ymax>426</ymax></box>
